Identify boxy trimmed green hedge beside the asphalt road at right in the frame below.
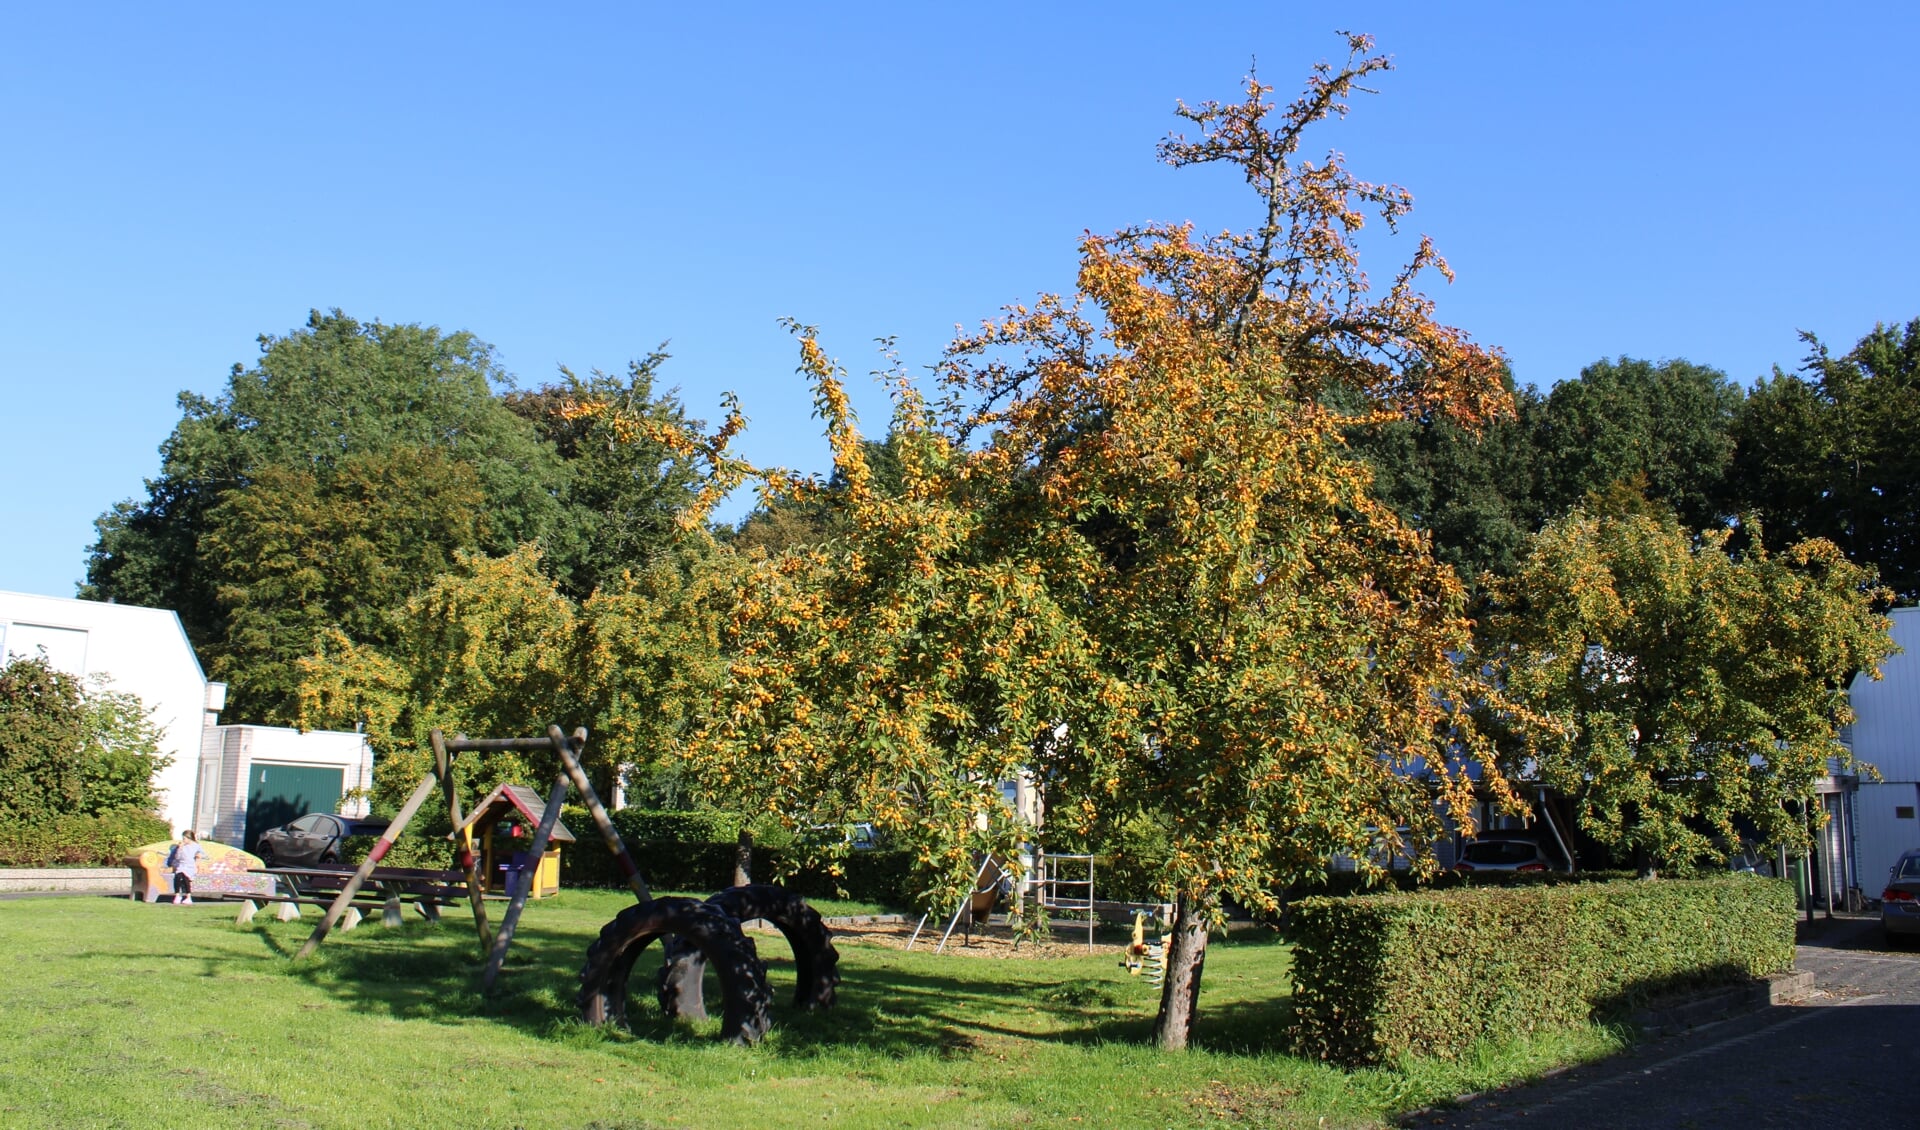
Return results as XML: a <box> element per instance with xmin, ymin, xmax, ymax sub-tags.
<box><xmin>1292</xmin><ymin>875</ymin><xmax>1793</xmax><ymax>1067</ymax></box>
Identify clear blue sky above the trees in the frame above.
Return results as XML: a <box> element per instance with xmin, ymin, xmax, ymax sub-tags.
<box><xmin>0</xmin><ymin>2</ymin><xmax>1920</xmax><ymax>595</ymax></box>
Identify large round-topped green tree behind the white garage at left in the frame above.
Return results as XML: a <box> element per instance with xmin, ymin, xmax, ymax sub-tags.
<box><xmin>81</xmin><ymin>311</ymin><xmax>564</xmax><ymax>721</ymax></box>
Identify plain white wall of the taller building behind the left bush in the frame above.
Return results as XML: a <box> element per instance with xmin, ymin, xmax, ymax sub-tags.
<box><xmin>0</xmin><ymin>593</ymin><xmax>225</xmax><ymax>831</ymax></box>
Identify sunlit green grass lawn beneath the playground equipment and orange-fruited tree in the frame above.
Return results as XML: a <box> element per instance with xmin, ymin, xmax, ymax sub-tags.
<box><xmin>0</xmin><ymin>892</ymin><xmax>1617</xmax><ymax>1130</ymax></box>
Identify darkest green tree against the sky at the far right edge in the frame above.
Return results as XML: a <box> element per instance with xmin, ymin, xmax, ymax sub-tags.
<box><xmin>1732</xmin><ymin>318</ymin><xmax>1920</xmax><ymax>600</ymax></box>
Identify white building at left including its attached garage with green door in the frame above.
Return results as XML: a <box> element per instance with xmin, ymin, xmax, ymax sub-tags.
<box><xmin>0</xmin><ymin>591</ymin><xmax>372</xmax><ymax>844</ymax></box>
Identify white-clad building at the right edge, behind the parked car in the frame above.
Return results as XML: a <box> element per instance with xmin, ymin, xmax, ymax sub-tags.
<box><xmin>1849</xmin><ymin>608</ymin><xmax>1920</xmax><ymax>898</ymax></box>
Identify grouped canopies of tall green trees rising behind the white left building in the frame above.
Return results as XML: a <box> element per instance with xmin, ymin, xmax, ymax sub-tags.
<box><xmin>81</xmin><ymin>311</ymin><xmax>693</xmax><ymax>723</ymax></box>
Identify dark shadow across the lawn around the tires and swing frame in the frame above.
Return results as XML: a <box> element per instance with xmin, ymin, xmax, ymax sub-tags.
<box><xmin>228</xmin><ymin>917</ymin><xmax>1284</xmax><ymax>1057</ymax></box>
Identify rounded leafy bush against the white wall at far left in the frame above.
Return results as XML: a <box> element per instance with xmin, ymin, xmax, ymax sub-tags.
<box><xmin>0</xmin><ymin>656</ymin><xmax>173</xmax><ymax>821</ymax></box>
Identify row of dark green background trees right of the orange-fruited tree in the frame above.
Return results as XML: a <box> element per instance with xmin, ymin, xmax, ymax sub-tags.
<box><xmin>1354</xmin><ymin>318</ymin><xmax>1920</xmax><ymax>602</ymax></box>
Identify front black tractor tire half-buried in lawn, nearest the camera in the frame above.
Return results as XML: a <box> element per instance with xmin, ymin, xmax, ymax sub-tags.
<box><xmin>580</xmin><ymin>898</ymin><xmax>770</xmax><ymax>1044</ymax></box>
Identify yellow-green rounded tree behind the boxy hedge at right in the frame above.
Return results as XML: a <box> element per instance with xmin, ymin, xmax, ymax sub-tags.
<box><xmin>1484</xmin><ymin>493</ymin><xmax>1893</xmax><ymax>869</ymax></box>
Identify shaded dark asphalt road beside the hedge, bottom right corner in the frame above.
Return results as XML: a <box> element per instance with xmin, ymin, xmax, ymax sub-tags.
<box><xmin>1409</xmin><ymin>921</ymin><xmax>1920</xmax><ymax>1130</ymax></box>
